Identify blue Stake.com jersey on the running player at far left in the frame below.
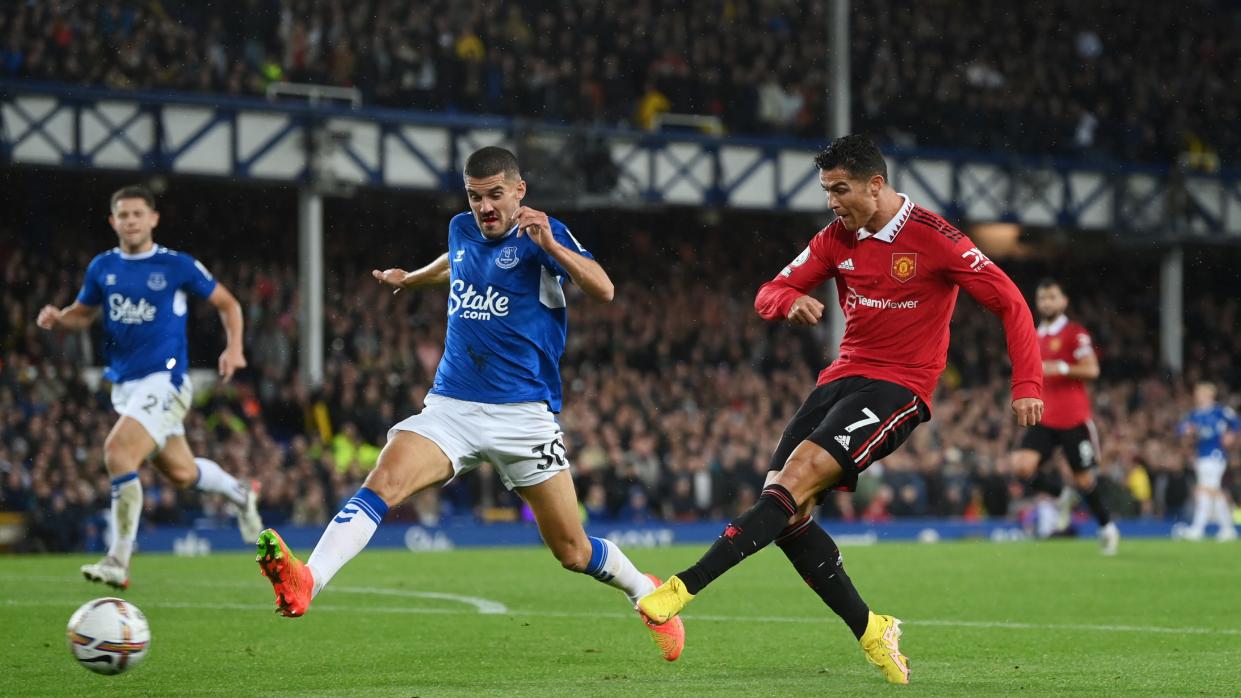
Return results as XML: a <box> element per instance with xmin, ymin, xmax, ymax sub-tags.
<box><xmin>77</xmin><ymin>245</ymin><xmax>216</xmax><ymax>386</ymax></box>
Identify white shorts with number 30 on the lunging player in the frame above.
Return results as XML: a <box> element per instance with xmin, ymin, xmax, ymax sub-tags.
<box><xmin>388</xmin><ymin>394</ymin><xmax>568</xmax><ymax>489</ymax></box>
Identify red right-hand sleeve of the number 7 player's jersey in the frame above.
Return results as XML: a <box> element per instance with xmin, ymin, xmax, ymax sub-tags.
<box><xmin>944</xmin><ymin>236</ymin><xmax>1042</xmax><ymax>400</ymax></box>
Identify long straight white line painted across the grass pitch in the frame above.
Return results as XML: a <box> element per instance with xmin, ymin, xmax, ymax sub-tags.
<box><xmin>0</xmin><ymin>588</ymin><xmax>1241</xmax><ymax>636</ymax></box>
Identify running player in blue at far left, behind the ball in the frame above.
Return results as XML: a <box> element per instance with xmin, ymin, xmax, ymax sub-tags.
<box><xmin>36</xmin><ymin>186</ymin><xmax>263</xmax><ymax>589</ymax></box>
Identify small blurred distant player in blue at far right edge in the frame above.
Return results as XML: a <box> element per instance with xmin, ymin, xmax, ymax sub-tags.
<box><xmin>1176</xmin><ymin>383</ymin><xmax>1241</xmax><ymax>542</ymax></box>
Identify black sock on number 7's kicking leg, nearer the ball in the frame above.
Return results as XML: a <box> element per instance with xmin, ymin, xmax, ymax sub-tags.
<box><xmin>676</xmin><ymin>484</ymin><xmax>797</xmax><ymax>594</ymax></box>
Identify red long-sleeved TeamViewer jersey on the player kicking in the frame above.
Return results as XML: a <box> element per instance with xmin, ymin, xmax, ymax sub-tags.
<box><xmin>755</xmin><ymin>194</ymin><xmax>1042</xmax><ymax>409</ymax></box>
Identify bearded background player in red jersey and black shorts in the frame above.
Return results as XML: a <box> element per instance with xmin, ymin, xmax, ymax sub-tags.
<box><xmin>1013</xmin><ymin>279</ymin><xmax>1121</xmax><ymax>555</ymax></box>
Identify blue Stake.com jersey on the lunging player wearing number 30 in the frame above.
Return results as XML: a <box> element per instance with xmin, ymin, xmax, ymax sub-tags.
<box><xmin>431</xmin><ymin>212</ymin><xmax>593</xmax><ymax>412</ymax></box>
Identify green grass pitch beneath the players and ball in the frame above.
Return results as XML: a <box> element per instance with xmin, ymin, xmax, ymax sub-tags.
<box><xmin>0</xmin><ymin>534</ymin><xmax>1241</xmax><ymax>697</ymax></box>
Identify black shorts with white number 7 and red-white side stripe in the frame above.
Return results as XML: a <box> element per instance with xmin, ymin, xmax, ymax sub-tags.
<box><xmin>771</xmin><ymin>376</ymin><xmax>931</xmax><ymax>492</ymax></box>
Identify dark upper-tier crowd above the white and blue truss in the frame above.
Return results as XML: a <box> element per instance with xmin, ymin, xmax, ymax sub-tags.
<box><xmin>0</xmin><ymin>0</ymin><xmax>1241</xmax><ymax>168</ymax></box>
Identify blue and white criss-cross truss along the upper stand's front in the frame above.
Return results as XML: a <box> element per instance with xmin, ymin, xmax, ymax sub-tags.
<box><xmin>0</xmin><ymin>81</ymin><xmax>1241</xmax><ymax>241</ymax></box>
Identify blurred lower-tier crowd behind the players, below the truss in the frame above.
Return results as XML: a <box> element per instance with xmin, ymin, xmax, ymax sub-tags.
<box><xmin>0</xmin><ymin>186</ymin><xmax>1241</xmax><ymax>550</ymax></box>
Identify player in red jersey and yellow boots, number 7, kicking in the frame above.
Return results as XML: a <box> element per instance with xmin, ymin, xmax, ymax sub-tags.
<box><xmin>638</xmin><ymin>135</ymin><xmax>1042</xmax><ymax>683</ymax></box>
